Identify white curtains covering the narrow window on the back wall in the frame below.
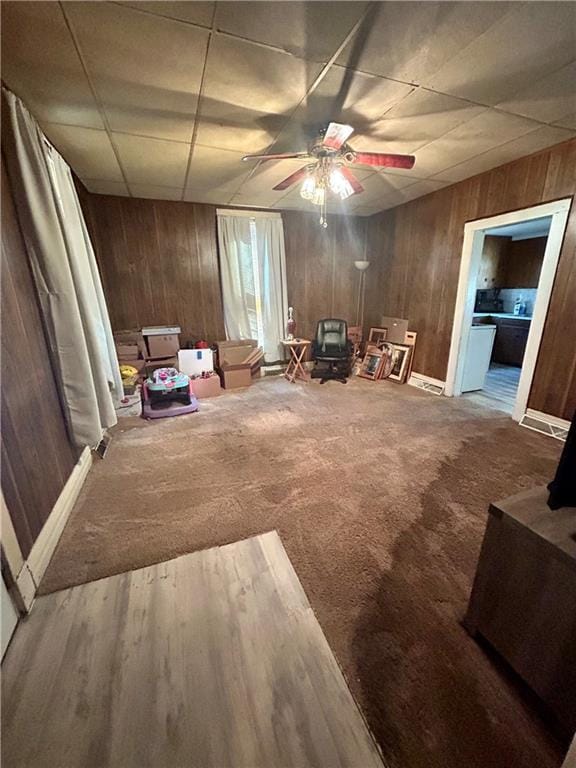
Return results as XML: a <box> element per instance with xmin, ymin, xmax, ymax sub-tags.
<box><xmin>218</xmin><ymin>210</ymin><xmax>288</xmax><ymax>363</ymax></box>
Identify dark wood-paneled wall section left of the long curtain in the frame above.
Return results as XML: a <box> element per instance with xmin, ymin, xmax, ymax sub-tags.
<box><xmin>1</xmin><ymin>162</ymin><xmax>77</xmax><ymax>557</ymax></box>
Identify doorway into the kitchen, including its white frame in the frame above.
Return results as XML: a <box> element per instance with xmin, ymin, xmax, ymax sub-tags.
<box><xmin>446</xmin><ymin>199</ymin><xmax>571</xmax><ymax>421</ymax></box>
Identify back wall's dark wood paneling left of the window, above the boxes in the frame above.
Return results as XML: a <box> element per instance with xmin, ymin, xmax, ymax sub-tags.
<box><xmin>79</xmin><ymin>195</ymin><xmax>224</xmax><ymax>341</ymax></box>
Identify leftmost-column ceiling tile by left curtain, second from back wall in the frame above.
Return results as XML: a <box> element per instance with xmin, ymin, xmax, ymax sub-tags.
<box><xmin>42</xmin><ymin>123</ymin><xmax>123</xmax><ymax>181</ymax></box>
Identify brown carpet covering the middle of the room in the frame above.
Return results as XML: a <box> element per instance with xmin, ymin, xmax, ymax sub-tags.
<box><xmin>42</xmin><ymin>379</ymin><xmax>561</xmax><ymax>768</ymax></box>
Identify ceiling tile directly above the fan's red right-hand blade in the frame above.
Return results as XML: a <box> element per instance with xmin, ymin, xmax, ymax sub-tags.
<box><xmin>350</xmin><ymin>88</ymin><xmax>486</xmax><ymax>154</ymax></box>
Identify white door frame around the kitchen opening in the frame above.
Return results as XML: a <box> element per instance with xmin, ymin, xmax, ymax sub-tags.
<box><xmin>445</xmin><ymin>197</ymin><xmax>572</xmax><ymax>421</ymax></box>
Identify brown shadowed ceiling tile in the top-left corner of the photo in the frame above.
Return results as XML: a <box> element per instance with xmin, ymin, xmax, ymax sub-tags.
<box><xmin>0</xmin><ymin>2</ymin><xmax>104</xmax><ymax>128</ymax></box>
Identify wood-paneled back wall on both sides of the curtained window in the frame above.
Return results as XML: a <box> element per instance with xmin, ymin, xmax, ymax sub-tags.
<box><xmin>79</xmin><ymin>188</ymin><xmax>367</xmax><ymax>342</ymax></box>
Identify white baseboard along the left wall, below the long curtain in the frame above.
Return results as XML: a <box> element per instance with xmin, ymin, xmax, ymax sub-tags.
<box><xmin>23</xmin><ymin>447</ymin><xmax>92</xmax><ymax>587</ymax></box>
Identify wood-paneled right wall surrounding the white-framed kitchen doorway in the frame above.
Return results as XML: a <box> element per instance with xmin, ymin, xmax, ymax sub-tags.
<box><xmin>367</xmin><ymin>140</ymin><xmax>576</xmax><ymax>419</ymax></box>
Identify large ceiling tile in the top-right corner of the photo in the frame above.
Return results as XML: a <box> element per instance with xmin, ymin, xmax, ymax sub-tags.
<box><xmin>423</xmin><ymin>2</ymin><xmax>576</xmax><ymax>105</ymax></box>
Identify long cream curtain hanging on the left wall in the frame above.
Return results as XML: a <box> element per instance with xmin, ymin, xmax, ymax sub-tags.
<box><xmin>2</xmin><ymin>88</ymin><xmax>122</xmax><ymax>448</ymax></box>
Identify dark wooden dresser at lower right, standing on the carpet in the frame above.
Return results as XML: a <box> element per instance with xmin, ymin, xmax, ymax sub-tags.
<box><xmin>464</xmin><ymin>488</ymin><xmax>576</xmax><ymax>735</ymax></box>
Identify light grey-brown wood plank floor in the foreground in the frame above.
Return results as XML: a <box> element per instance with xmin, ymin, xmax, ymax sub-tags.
<box><xmin>2</xmin><ymin>532</ymin><xmax>383</xmax><ymax>768</ymax></box>
